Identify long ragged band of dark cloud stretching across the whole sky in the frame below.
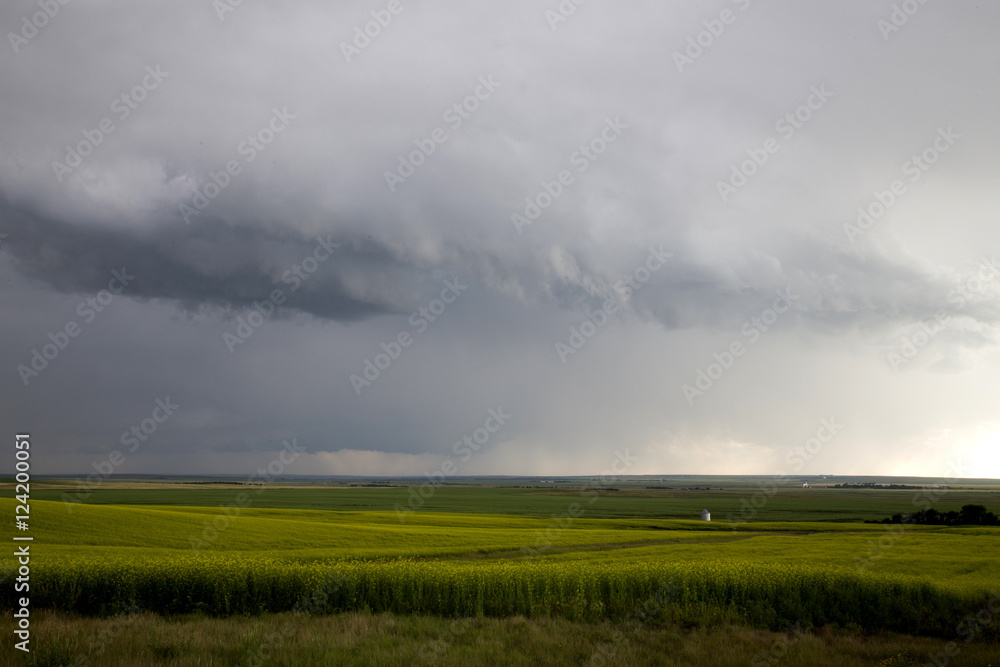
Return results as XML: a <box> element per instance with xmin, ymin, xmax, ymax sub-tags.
<box><xmin>0</xmin><ymin>188</ymin><xmax>984</xmax><ymax>344</ymax></box>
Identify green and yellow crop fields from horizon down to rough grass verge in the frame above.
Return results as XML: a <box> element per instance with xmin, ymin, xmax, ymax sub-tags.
<box><xmin>0</xmin><ymin>484</ymin><xmax>1000</xmax><ymax>664</ymax></box>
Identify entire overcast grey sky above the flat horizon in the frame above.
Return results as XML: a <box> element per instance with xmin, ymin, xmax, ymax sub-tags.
<box><xmin>0</xmin><ymin>0</ymin><xmax>1000</xmax><ymax>479</ymax></box>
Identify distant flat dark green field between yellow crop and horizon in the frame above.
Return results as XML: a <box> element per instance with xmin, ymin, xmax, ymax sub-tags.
<box><xmin>25</xmin><ymin>478</ymin><xmax>1000</xmax><ymax>522</ymax></box>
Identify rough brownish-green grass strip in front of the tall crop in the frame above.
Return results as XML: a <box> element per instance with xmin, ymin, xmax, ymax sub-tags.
<box><xmin>0</xmin><ymin>612</ymin><xmax>1000</xmax><ymax>667</ymax></box>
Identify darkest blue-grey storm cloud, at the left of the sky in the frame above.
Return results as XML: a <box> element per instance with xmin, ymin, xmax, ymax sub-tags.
<box><xmin>0</xmin><ymin>197</ymin><xmax>396</xmax><ymax>321</ymax></box>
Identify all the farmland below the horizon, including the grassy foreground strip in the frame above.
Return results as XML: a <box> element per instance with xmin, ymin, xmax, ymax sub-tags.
<box><xmin>0</xmin><ymin>483</ymin><xmax>1000</xmax><ymax>665</ymax></box>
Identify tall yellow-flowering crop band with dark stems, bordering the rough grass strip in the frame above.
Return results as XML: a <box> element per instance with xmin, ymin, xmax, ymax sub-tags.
<box><xmin>9</xmin><ymin>557</ymin><xmax>987</xmax><ymax>635</ymax></box>
